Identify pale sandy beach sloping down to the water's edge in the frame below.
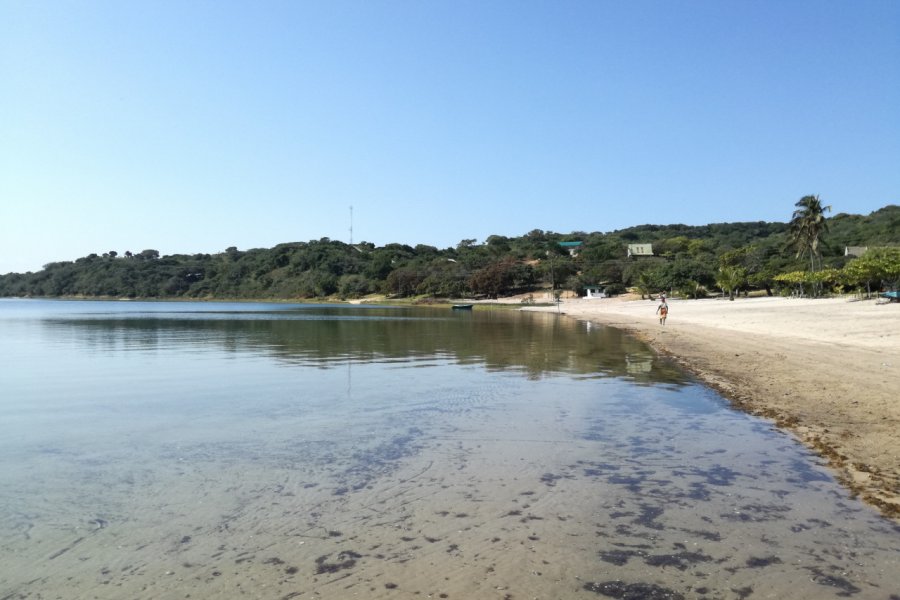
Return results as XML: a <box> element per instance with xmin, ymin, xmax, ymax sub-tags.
<box><xmin>534</xmin><ymin>298</ymin><xmax>900</xmax><ymax>519</ymax></box>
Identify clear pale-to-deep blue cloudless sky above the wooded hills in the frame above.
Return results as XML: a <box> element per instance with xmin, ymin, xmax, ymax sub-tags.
<box><xmin>0</xmin><ymin>0</ymin><xmax>900</xmax><ymax>273</ymax></box>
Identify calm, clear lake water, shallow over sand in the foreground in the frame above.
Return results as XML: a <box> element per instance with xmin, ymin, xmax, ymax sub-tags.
<box><xmin>0</xmin><ymin>300</ymin><xmax>900</xmax><ymax>600</ymax></box>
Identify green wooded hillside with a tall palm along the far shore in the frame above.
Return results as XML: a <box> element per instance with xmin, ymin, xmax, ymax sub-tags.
<box><xmin>0</xmin><ymin>205</ymin><xmax>900</xmax><ymax>299</ymax></box>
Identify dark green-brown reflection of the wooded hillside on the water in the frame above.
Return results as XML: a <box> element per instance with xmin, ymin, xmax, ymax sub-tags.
<box><xmin>31</xmin><ymin>304</ymin><xmax>684</xmax><ymax>383</ymax></box>
